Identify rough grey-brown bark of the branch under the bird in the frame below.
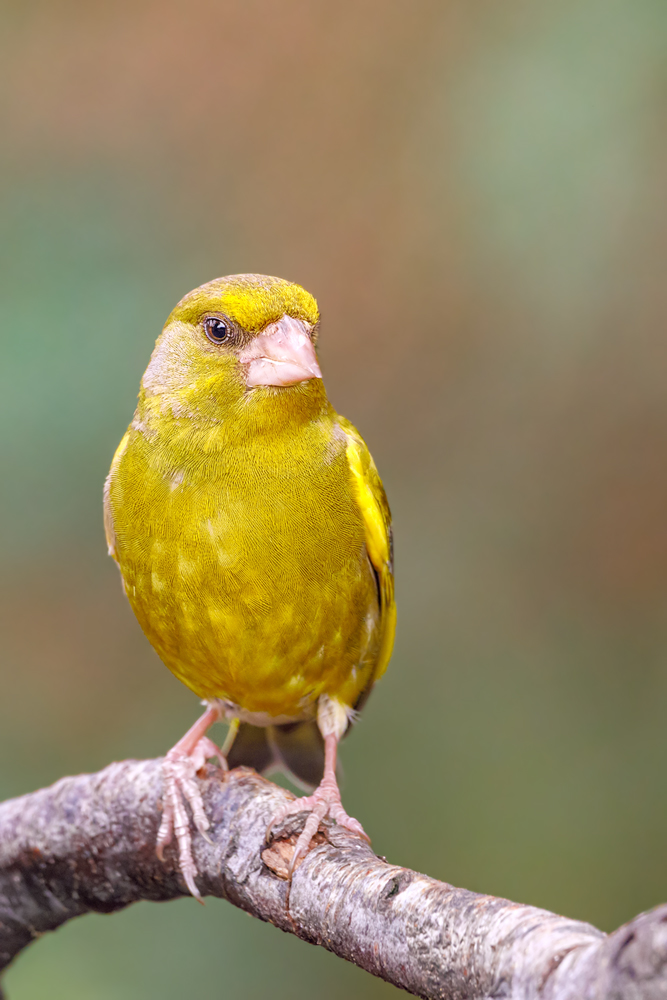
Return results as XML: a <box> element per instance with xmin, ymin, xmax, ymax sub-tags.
<box><xmin>0</xmin><ymin>760</ymin><xmax>667</xmax><ymax>1000</ymax></box>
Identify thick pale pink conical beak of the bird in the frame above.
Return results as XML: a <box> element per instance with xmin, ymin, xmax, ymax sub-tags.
<box><xmin>239</xmin><ymin>316</ymin><xmax>322</xmax><ymax>386</ymax></box>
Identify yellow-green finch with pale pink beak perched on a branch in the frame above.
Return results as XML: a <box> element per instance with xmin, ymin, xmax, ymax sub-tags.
<box><xmin>104</xmin><ymin>274</ymin><xmax>396</xmax><ymax>899</ymax></box>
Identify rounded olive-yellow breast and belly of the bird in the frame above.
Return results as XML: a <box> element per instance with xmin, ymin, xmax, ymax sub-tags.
<box><xmin>109</xmin><ymin>418</ymin><xmax>379</xmax><ymax>716</ymax></box>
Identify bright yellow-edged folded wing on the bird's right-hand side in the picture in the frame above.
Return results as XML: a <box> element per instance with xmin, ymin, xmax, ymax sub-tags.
<box><xmin>338</xmin><ymin>417</ymin><xmax>396</xmax><ymax>688</ymax></box>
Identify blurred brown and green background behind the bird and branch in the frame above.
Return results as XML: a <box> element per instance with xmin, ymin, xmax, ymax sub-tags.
<box><xmin>0</xmin><ymin>0</ymin><xmax>667</xmax><ymax>1000</ymax></box>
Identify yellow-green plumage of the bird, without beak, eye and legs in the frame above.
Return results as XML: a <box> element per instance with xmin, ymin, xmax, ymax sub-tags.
<box><xmin>105</xmin><ymin>275</ymin><xmax>394</xmax><ymax>788</ymax></box>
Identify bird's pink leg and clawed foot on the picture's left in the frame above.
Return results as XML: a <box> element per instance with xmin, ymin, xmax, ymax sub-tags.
<box><xmin>155</xmin><ymin>703</ymin><xmax>227</xmax><ymax>899</ymax></box>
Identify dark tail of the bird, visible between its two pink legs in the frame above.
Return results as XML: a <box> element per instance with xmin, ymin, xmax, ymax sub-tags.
<box><xmin>224</xmin><ymin>720</ymin><xmax>324</xmax><ymax>791</ymax></box>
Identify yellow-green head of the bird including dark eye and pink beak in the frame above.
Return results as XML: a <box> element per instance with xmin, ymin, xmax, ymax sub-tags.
<box><xmin>142</xmin><ymin>274</ymin><xmax>326</xmax><ymax>417</ymax></box>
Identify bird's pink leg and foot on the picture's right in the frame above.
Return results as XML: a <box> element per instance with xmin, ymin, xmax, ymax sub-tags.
<box><xmin>267</xmin><ymin>695</ymin><xmax>370</xmax><ymax>878</ymax></box>
